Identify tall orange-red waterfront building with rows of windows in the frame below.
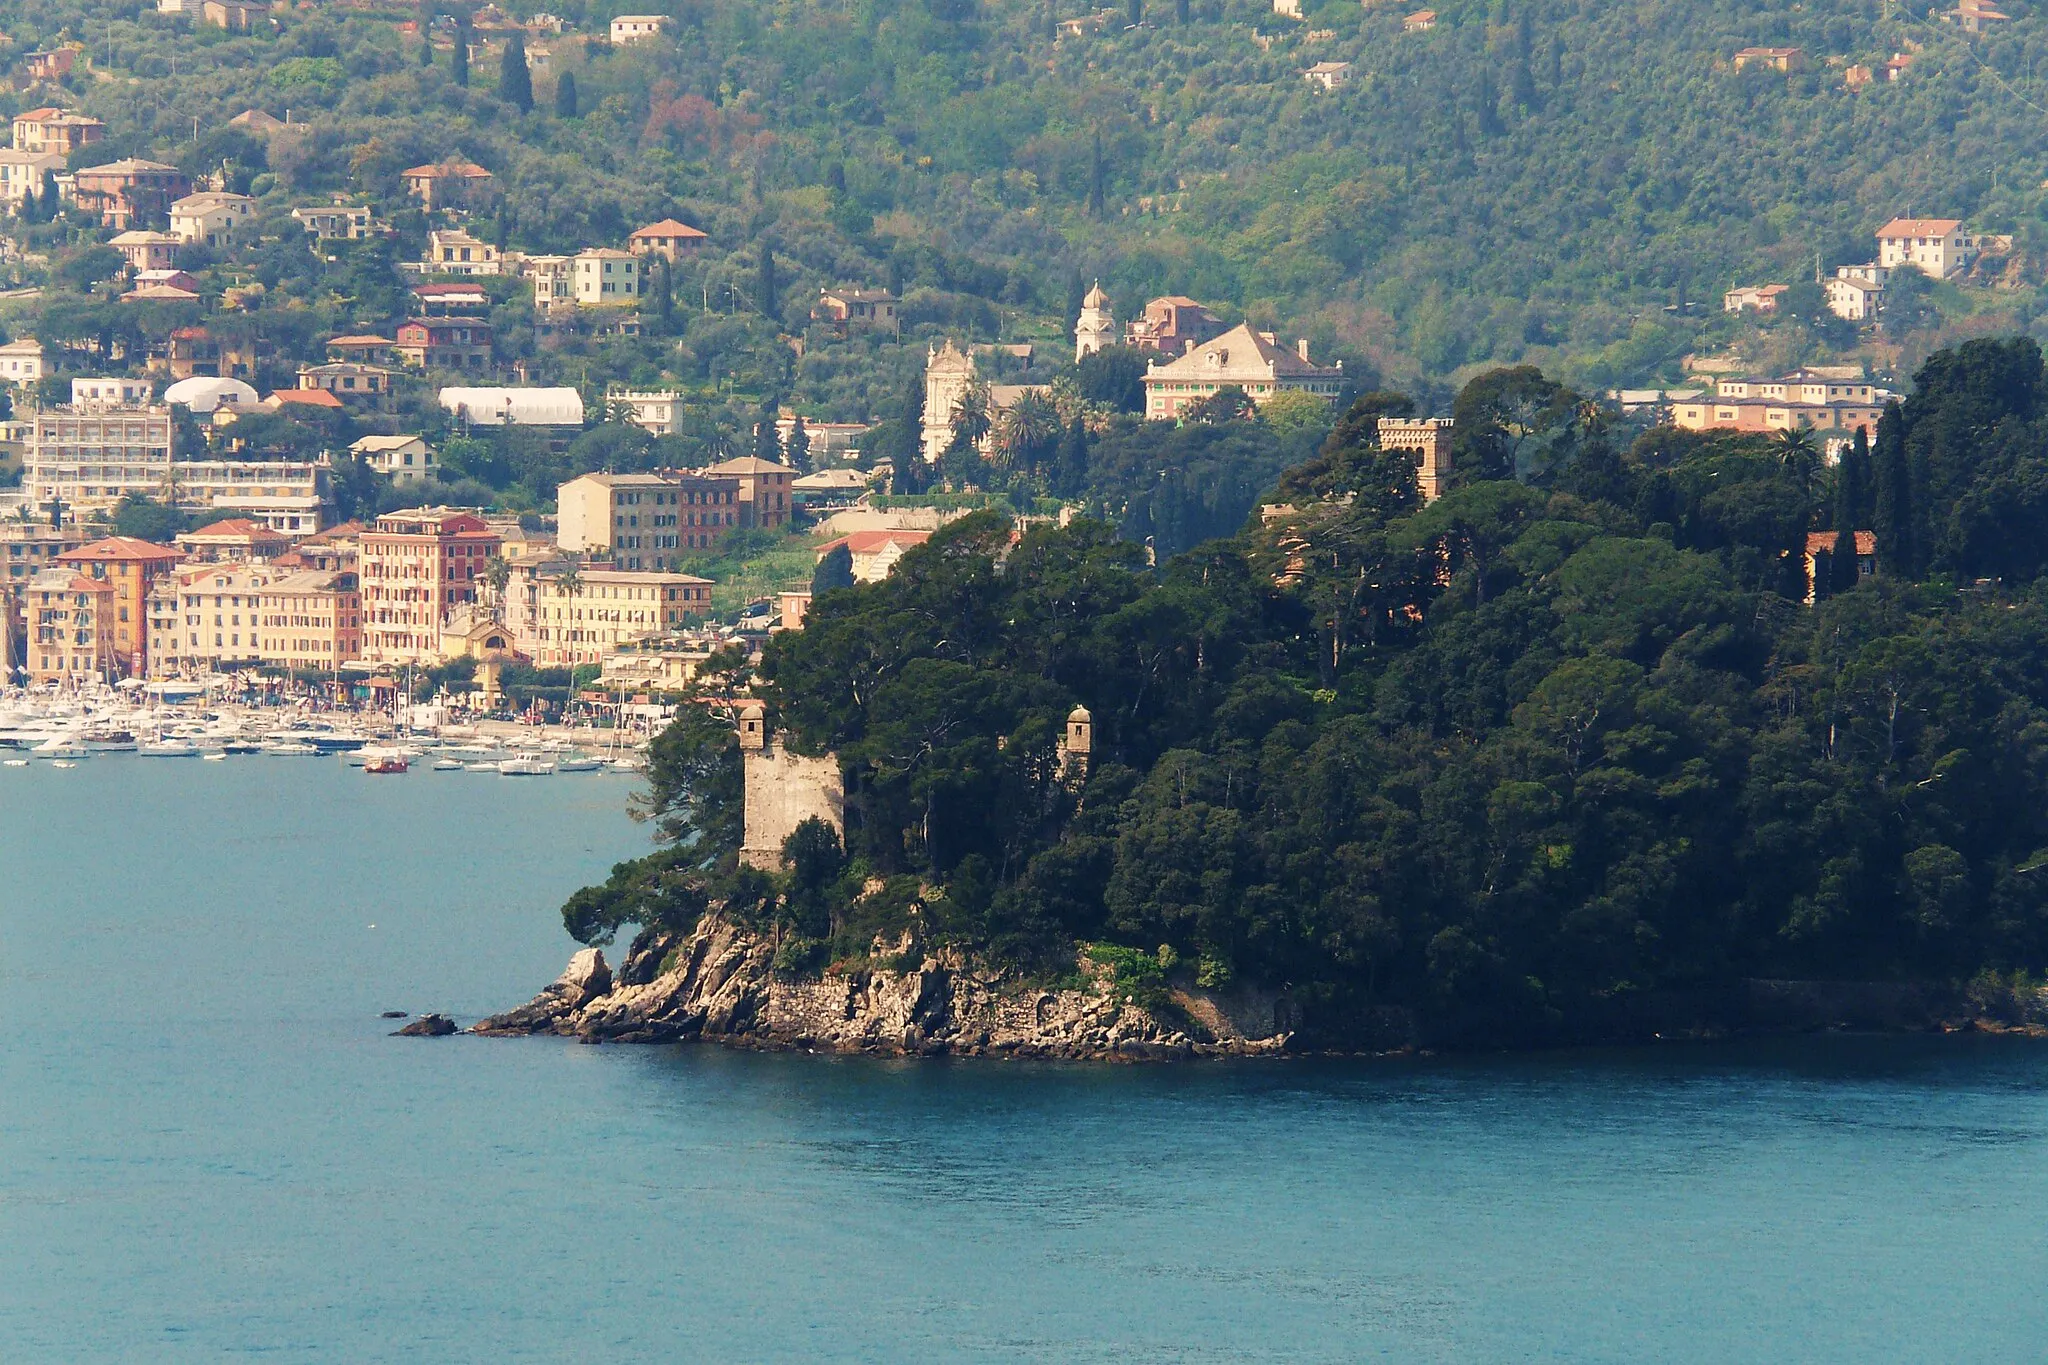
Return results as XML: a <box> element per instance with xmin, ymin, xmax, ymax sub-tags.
<box><xmin>356</xmin><ymin>508</ymin><xmax>502</xmax><ymax>663</ymax></box>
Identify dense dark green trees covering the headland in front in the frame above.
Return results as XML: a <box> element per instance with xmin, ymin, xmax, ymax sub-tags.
<box><xmin>565</xmin><ymin>340</ymin><xmax>2048</xmax><ymax>1040</ymax></box>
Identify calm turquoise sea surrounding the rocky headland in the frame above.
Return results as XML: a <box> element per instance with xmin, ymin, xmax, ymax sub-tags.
<box><xmin>0</xmin><ymin>757</ymin><xmax>2048</xmax><ymax>1363</ymax></box>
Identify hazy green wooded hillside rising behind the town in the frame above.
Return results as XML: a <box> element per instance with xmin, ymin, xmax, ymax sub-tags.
<box><xmin>12</xmin><ymin>0</ymin><xmax>2048</xmax><ymax>420</ymax></box>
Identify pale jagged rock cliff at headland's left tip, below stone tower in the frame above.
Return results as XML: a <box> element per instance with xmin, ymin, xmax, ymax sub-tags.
<box><xmin>471</xmin><ymin>915</ymin><xmax>1292</xmax><ymax>1060</ymax></box>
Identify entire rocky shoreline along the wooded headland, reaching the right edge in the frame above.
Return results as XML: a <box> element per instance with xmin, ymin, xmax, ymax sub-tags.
<box><xmin>460</xmin><ymin>913</ymin><xmax>2048</xmax><ymax>1062</ymax></box>
